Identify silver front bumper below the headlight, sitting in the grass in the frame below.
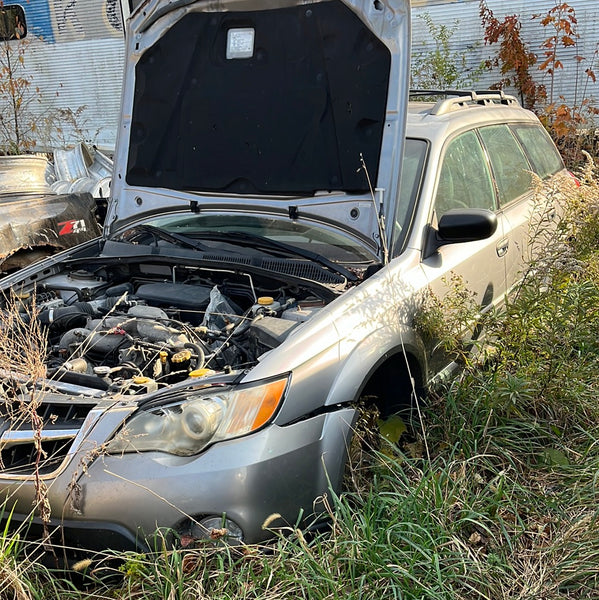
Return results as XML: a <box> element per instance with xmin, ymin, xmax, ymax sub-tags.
<box><xmin>0</xmin><ymin>408</ymin><xmax>355</xmax><ymax>550</ymax></box>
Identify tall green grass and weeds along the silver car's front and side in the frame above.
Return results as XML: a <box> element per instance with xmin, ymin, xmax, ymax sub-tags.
<box><xmin>0</xmin><ymin>164</ymin><xmax>599</xmax><ymax>600</ymax></box>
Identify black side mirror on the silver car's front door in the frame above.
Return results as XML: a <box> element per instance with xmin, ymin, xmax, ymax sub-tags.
<box><xmin>425</xmin><ymin>208</ymin><xmax>497</xmax><ymax>256</ymax></box>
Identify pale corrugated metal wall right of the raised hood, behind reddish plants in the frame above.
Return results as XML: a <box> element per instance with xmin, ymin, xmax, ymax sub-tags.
<box><xmin>412</xmin><ymin>0</ymin><xmax>599</xmax><ymax>107</ymax></box>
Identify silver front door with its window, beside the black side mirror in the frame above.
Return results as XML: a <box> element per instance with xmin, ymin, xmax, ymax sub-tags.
<box><xmin>422</xmin><ymin>129</ymin><xmax>507</xmax><ymax>372</ymax></box>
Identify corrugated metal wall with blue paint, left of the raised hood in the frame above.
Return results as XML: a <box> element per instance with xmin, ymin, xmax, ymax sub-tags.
<box><xmin>10</xmin><ymin>0</ymin><xmax>124</xmax><ymax>149</ymax></box>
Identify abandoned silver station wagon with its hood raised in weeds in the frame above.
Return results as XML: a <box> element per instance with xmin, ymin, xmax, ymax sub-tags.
<box><xmin>0</xmin><ymin>0</ymin><xmax>563</xmax><ymax>549</ymax></box>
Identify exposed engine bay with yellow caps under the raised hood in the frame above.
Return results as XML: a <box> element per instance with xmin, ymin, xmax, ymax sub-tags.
<box><xmin>7</xmin><ymin>259</ymin><xmax>337</xmax><ymax>394</ymax></box>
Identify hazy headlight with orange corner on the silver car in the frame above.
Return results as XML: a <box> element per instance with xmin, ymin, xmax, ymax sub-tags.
<box><xmin>106</xmin><ymin>377</ymin><xmax>288</xmax><ymax>456</ymax></box>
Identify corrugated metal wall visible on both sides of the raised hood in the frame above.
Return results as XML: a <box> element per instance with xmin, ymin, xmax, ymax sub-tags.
<box><xmin>4</xmin><ymin>0</ymin><xmax>599</xmax><ymax>149</ymax></box>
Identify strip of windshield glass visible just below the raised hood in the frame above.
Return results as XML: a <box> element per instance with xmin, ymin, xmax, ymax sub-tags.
<box><xmin>118</xmin><ymin>213</ymin><xmax>376</xmax><ymax>264</ymax></box>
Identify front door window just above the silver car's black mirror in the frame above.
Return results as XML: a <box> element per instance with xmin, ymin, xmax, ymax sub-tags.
<box><xmin>435</xmin><ymin>131</ymin><xmax>497</xmax><ymax>218</ymax></box>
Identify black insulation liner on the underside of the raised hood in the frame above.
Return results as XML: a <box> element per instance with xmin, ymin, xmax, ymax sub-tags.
<box><xmin>126</xmin><ymin>0</ymin><xmax>391</xmax><ymax>195</ymax></box>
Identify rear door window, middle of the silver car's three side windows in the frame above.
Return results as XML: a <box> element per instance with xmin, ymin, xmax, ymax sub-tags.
<box><xmin>479</xmin><ymin>125</ymin><xmax>532</xmax><ymax>204</ymax></box>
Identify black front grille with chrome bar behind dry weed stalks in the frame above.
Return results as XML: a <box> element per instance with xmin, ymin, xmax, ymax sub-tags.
<box><xmin>0</xmin><ymin>399</ymin><xmax>95</xmax><ymax>475</ymax></box>
